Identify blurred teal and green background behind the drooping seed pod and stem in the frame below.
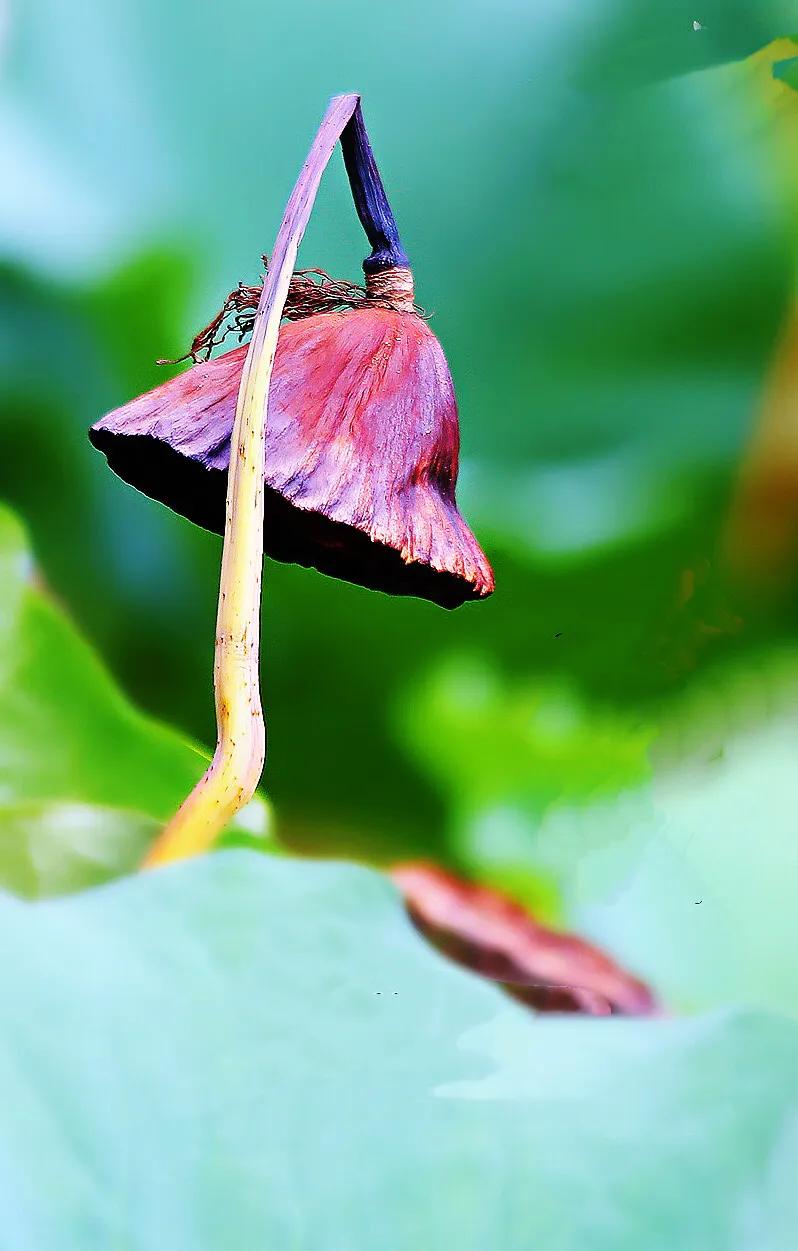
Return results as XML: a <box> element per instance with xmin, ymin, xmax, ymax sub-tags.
<box><xmin>0</xmin><ymin>0</ymin><xmax>798</xmax><ymax>1011</ymax></box>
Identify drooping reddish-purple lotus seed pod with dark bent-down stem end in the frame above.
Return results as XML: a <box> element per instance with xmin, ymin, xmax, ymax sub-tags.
<box><xmin>90</xmin><ymin>110</ymin><xmax>494</xmax><ymax>608</ymax></box>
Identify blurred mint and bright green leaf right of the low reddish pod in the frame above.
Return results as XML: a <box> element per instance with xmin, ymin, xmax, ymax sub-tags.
<box><xmin>398</xmin><ymin>648</ymin><xmax>798</xmax><ymax>1013</ymax></box>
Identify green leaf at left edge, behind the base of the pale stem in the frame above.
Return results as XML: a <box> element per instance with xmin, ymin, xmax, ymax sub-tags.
<box><xmin>0</xmin><ymin>508</ymin><xmax>273</xmax><ymax>894</ymax></box>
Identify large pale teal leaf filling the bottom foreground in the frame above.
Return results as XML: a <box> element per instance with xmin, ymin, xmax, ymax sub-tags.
<box><xmin>0</xmin><ymin>852</ymin><xmax>798</xmax><ymax>1251</ymax></box>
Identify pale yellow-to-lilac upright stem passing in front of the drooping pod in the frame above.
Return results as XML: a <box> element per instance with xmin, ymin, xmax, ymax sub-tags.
<box><xmin>145</xmin><ymin>95</ymin><xmax>358</xmax><ymax>867</ymax></box>
